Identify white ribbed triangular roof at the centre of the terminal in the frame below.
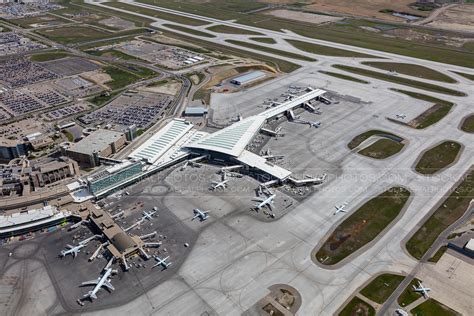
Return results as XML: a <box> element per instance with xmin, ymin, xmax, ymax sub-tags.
<box><xmin>186</xmin><ymin>115</ymin><xmax>266</xmax><ymax>157</ymax></box>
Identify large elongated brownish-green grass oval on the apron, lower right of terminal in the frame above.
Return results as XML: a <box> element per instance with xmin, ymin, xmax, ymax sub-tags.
<box><xmin>316</xmin><ymin>187</ymin><xmax>410</xmax><ymax>265</ymax></box>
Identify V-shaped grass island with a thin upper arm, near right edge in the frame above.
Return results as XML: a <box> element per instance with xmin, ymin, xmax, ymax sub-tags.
<box><xmin>391</xmin><ymin>89</ymin><xmax>454</xmax><ymax>129</ymax></box>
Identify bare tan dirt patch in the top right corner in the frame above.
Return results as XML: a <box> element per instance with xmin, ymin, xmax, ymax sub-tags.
<box><xmin>426</xmin><ymin>5</ymin><xmax>474</xmax><ymax>33</ymax></box>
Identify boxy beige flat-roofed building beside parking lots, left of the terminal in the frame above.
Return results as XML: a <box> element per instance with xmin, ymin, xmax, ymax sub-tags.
<box><xmin>64</xmin><ymin>129</ymin><xmax>127</xmax><ymax>167</ymax></box>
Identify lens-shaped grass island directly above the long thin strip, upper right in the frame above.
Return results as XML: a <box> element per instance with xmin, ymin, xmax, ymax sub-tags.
<box><xmin>362</xmin><ymin>61</ymin><xmax>457</xmax><ymax>83</ymax></box>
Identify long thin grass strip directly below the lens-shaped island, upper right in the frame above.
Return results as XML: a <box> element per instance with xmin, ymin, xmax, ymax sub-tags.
<box><xmin>333</xmin><ymin>64</ymin><xmax>466</xmax><ymax>97</ymax></box>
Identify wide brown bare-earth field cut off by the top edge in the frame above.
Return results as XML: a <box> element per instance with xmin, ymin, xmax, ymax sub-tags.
<box><xmin>304</xmin><ymin>0</ymin><xmax>427</xmax><ymax>21</ymax></box>
